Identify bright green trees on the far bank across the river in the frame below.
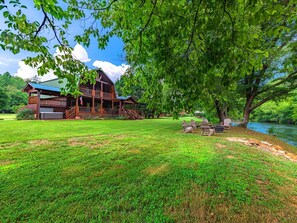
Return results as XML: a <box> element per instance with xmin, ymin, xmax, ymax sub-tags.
<box><xmin>252</xmin><ymin>92</ymin><xmax>297</xmax><ymax>124</ymax></box>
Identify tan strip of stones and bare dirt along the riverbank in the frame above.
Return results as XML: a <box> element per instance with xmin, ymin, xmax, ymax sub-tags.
<box><xmin>226</xmin><ymin>137</ymin><xmax>297</xmax><ymax>162</ymax></box>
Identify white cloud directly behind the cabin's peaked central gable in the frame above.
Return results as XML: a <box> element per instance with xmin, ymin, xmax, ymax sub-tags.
<box><xmin>93</xmin><ymin>60</ymin><xmax>129</xmax><ymax>82</ymax></box>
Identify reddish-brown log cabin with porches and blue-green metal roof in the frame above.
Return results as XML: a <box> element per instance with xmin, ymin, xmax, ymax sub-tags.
<box><xmin>23</xmin><ymin>70</ymin><xmax>142</xmax><ymax>119</ymax></box>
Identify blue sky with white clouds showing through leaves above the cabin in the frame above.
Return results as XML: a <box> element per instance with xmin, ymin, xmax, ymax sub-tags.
<box><xmin>0</xmin><ymin>1</ymin><xmax>128</xmax><ymax>81</ymax></box>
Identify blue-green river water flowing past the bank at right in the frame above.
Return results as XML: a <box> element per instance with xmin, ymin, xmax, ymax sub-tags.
<box><xmin>248</xmin><ymin>122</ymin><xmax>297</xmax><ymax>147</ymax></box>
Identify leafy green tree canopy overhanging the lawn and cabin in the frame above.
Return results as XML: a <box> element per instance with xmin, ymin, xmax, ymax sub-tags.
<box><xmin>0</xmin><ymin>0</ymin><xmax>297</xmax><ymax>126</ymax></box>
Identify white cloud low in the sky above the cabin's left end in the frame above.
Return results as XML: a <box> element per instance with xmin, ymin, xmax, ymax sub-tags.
<box><xmin>14</xmin><ymin>61</ymin><xmax>57</xmax><ymax>81</ymax></box>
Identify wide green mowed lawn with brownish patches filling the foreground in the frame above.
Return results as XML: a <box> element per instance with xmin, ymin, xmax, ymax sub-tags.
<box><xmin>0</xmin><ymin>119</ymin><xmax>297</xmax><ymax>222</ymax></box>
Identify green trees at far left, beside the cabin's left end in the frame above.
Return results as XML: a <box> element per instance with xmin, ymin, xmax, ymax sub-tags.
<box><xmin>0</xmin><ymin>72</ymin><xmax>28</xmax><ymax>113</ymax></box>
